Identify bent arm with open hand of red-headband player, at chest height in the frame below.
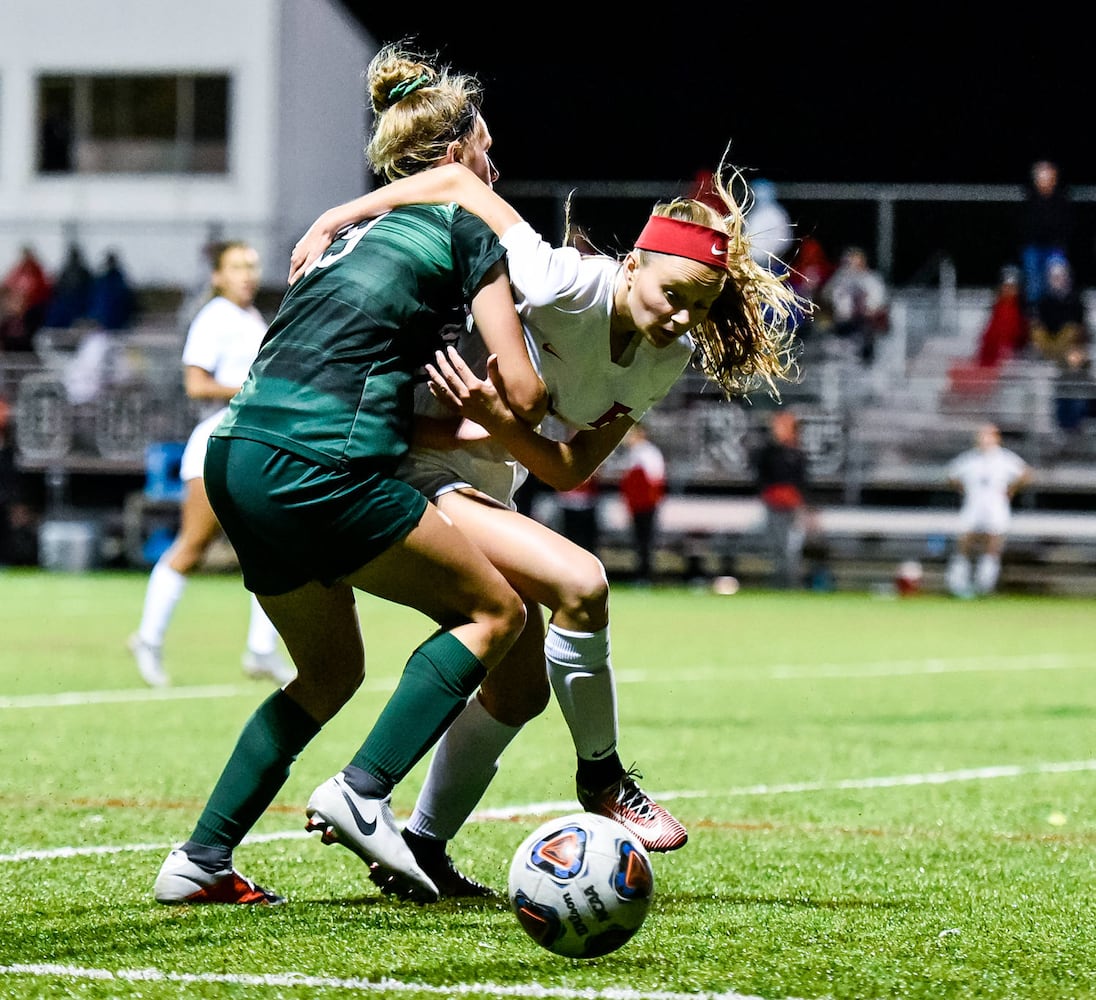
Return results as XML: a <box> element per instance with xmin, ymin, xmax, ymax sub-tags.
<box><xmin>426</xmin><ymin>348</ymin><xmax>635</xmax><ymax>490</ymax></box>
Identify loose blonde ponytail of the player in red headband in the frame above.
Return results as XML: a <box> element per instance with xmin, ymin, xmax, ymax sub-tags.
<box><xmin>635</xmin><ymin>162</ymin><xmax>814</xmax><ymax>400</ymax></box>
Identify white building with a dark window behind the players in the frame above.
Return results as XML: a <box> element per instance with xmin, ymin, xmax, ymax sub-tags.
<box><xmin>0</xmin><ymin>0</ymin><xmax>377</xmax><ymax>288</ymax></box>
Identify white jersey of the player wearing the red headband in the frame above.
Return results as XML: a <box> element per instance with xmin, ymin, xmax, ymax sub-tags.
<box><xmin>400</xmin><ymin>223</ymin><xmax>694</xmax><ymax>507</ymax></box>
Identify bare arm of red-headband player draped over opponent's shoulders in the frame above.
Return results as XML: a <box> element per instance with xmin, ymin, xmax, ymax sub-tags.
<box><xmin>289</xmin><ymin>163</ymin><xmax>522</xmax><ymax>285</ymax></box>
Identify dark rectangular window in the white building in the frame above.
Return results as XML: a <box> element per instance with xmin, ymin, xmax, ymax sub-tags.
<box><xmin>38</xmin><ymin>73</ymin><xmax>230</xmax><ymax>174</ymax></box>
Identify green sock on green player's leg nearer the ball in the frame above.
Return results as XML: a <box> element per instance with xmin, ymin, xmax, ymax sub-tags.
<box><xmin>351</xmin><ymin>632</ymin><xmax>487</xmax><ymax>792</ymax></box>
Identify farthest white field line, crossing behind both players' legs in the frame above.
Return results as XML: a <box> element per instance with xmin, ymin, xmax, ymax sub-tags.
<box><xmin>0</xmin><ymin>654</ymin><xmax>1082</xmax><ymax>709</ymax></box>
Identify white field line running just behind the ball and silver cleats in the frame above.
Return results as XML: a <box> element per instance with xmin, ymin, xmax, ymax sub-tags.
<box><xmin>0</xmin><ymin>759</ymin><xmax>1096</xmax><ymax>864</ymax></box>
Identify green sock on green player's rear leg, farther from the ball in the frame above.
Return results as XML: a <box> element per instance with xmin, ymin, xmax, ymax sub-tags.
<box><xmin>191</xmin><ymin>691</ymin><xmax>320</xmax><ymax>853</ymax></box>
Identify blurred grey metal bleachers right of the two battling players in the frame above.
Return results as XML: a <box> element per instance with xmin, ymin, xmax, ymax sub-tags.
<box><xmin>561</xmin><ymin>280</ymin><xmax>1096</xmax><ymax>593</ymax></box>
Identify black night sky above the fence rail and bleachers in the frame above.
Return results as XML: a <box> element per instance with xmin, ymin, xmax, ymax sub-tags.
<box><xmin>344</xmin><ymin>7</ymin><xmax>1096</xmax><ymax>184</ymax></box>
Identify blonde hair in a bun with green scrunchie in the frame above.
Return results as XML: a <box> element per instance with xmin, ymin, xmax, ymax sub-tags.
<box><xmin>365</xmin><ymin>43</ymin><xmax>483</xmax><ymax>181</ymax></box>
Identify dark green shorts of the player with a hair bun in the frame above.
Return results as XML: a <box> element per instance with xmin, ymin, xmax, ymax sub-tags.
<box><xmin>205</xmin><ymin>438</ymin><xmax>427</xmax><ymax>595</ymax></box>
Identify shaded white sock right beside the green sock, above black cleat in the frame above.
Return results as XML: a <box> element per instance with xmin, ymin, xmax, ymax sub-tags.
<box><xmin>407</xmin><ymin>694</ymin><xmax>521</xmax><ymax>840</ymax></box>
